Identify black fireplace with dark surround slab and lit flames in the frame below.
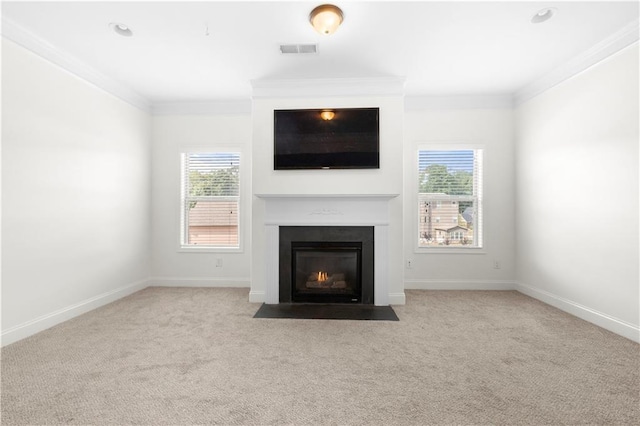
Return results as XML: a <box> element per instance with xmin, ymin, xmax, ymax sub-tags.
<box><xmin>279</xmin><ymin>226</ymin><xmax>374</xmax><ymax>304</ymax></box>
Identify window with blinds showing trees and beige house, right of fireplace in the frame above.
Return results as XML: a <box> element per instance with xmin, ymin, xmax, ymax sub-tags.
<box><xmin>418</xmin><ymin>149</ymin><xmax>482</xmax><ymax>248</ymax></box>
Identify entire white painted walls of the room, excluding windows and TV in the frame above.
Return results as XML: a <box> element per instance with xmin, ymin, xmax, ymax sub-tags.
<box><xmin>2</xmin><ymin>26</ymin><xmax>640</xmax><ymax>344</ymax></box>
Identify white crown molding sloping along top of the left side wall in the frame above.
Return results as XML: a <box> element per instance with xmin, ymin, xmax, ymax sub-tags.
<box><xmin>2</xmin><ymin>16</ymin><xmax>151</xmax><ymax>112</ymax></box>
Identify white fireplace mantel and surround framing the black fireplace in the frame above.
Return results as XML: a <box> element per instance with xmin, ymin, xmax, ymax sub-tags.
<box><xmin>256</xmin><ymin>194</ymin><xmax>399</xmax><ymax>306</ymax></box>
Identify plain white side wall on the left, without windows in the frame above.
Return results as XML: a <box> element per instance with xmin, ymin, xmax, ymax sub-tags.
<box><xmin>2</xmin><ymin>39</ymin><xmax>150</xmax><ymax>344</ymax></box>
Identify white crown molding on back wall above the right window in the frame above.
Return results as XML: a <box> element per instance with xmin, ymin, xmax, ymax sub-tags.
<box><xmin>404</xmin><ymin>95</ymin><xmax>513</xmax><ymax>111</ymax></box>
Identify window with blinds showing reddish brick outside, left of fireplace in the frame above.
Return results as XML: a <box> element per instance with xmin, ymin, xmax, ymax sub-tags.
<box><xmin>181</xmin><ymin>152</ymin><xmax>240</xmax><ymax>249</ymax></box>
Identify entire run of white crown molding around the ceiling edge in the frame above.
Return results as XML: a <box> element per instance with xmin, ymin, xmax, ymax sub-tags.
<box><xmin>1</xmin><ymin>12</ymin><xmax>640</xmax><ymax>115</ymax></box>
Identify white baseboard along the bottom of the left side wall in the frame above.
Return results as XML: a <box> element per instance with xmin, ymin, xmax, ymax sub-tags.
<box><xmin>0</xmin><ymin>279</ymin><xmax>148</xmax><ymax>346</ymax></box>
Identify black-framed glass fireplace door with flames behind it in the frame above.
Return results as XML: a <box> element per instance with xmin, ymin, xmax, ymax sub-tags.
<box><xmin>291</xmin><ymin>241</ymin><xmax>362</xmax><ymax>303</ymax></box>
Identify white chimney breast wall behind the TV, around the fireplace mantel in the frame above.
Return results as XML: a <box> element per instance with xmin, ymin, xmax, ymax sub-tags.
<box><xmin>251</xmin><ymin>96</ymin><xmax>404</xmax><ymax>303</ymax></box>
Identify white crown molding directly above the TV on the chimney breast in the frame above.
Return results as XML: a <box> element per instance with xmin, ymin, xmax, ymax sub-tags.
<box><xmin>251</xmin><ymin>77</ymin><xmax>404</xmax><ymax>99</ymax></box>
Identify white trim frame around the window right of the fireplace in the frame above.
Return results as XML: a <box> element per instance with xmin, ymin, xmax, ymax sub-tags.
<box><xmin>410</xmin><ymin>142</ymin><xmax>487</xmax><ymax>254</ymax></box>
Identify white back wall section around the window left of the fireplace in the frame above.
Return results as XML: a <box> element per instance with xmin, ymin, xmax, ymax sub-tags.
<box><xmin>151</xmin><ymin>114</ymin><xmax>251</xmax><ymax>287</ymax></box>
